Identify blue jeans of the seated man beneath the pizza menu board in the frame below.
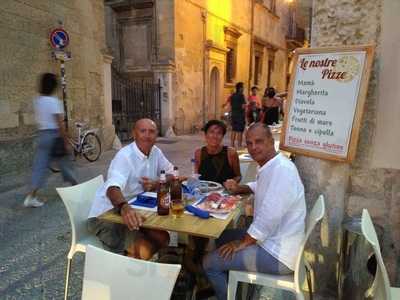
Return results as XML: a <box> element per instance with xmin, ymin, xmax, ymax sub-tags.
<box><xmin>203</xmin><ymin>229</ymin><xmax>293</xmax><ymax>300</ymax></box>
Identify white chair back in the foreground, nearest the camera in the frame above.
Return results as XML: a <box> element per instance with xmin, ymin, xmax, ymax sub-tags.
<box><xmin>82</xmin><ymin>245</ymin><xmax>181</xmax><ymax>300</ymax></box>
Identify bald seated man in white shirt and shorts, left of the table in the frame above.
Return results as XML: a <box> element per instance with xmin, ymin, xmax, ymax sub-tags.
<box><xmin>88</xmin><ymin>119</ymin><xmax>173</xmax><ymax>260</ymax></box>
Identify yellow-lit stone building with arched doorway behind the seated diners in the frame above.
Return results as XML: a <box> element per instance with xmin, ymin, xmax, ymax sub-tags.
<box><xmin>106</xmin><ymin>0</ymin><xmax>304</xmax><ymax>134</ymax></box>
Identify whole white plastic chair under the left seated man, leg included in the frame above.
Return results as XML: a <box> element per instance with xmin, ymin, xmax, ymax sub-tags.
<box><xmin>56</xmin><ymin>175</ymin><xmax>104</xmax><ymax>299</ymax></box>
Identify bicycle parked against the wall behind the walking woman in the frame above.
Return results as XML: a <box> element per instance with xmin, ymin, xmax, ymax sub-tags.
<box><xmin>49</xmin><ymin>122</ymin><xmax>101</xmax><ymax>172</ymax></box>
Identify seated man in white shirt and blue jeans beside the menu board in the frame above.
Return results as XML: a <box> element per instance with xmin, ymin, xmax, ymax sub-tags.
<box><xmin>203</xmin><ymin>123</ymin><xmax>306</xmax><ymax>300</ymax></box>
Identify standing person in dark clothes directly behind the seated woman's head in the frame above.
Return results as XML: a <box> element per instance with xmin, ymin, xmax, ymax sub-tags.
<box><xmin>230</xmin><ymin>82</ymin><xmax>246</xmax><ymax>148</ymax></box>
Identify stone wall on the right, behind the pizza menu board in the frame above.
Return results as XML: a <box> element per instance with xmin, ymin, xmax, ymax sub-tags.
<box><xmin>296</xmin><ymin>0</ymin><xmax>400</xmax><ymax>299</ymax></box>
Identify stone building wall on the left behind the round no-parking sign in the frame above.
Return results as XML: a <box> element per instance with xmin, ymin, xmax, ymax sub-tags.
<box><xmin>0</xmin><ymin>0</ymin><xmax>114</xmax><ymax>175</ymax></box>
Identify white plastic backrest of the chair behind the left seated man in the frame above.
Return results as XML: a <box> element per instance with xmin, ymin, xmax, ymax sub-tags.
<box><xmin>56</xmin><ymin>175</ymin><xmax>104</xmax><ymax>249</ymax></box>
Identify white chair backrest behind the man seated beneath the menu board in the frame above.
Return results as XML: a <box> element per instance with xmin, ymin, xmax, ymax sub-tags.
<box><xmin>294</xmin><ymin>195</ymin><xmax>325</xmax><ymax>293</ymax></box>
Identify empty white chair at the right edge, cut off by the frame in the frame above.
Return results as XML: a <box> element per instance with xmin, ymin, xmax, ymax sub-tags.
<box><xmin>361</xmin><ymin>209</ymin><xmax>400</xmax><ymax>300</ymax></box>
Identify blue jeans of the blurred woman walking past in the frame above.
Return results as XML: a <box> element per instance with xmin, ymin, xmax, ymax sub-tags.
<box><xmin>32</xmin><ymin>129</ymin><xmax>77</xmax><ymax>190</ymax></box>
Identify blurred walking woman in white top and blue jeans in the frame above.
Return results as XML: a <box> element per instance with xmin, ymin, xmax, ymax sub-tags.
<box><xmin>24</xmin><ymin>73</ymin><xmax>77</xmax><ymax>207</ymax></box>
